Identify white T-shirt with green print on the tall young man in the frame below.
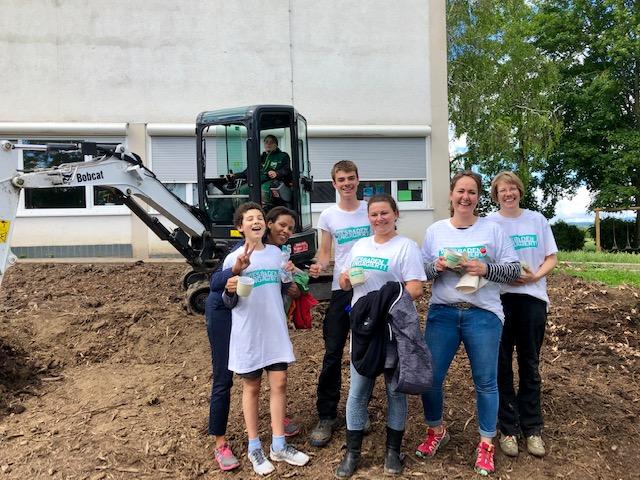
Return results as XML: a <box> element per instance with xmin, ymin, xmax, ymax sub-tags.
<box><xmin>318</xmin><ymin>201</ymin><xmax>371</xmax><ymax>290</ymax></box>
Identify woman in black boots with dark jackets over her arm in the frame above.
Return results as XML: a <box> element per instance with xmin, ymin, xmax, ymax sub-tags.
<box><xmin>336</xmin><ymin>194</ymin><xmax>426</xmax><ymax>478</ymax></box>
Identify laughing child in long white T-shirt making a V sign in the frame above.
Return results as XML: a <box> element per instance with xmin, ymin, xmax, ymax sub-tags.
<box><xmin>223</xmin><ymin>202</ymin><xmax>309</xmax><ymax>475</ymax></box>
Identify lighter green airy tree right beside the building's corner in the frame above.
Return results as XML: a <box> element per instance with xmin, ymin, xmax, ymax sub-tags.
<box><xmin>447</xmin><ymin>0</ymin><xmax>564</xmax><ymax>215</ymax></box>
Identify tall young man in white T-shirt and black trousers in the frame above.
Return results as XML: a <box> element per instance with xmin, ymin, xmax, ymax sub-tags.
<box><xmin>309</xmin><ymin>160</ymin><xmax>371</xmax><ymax>447</ymax></box>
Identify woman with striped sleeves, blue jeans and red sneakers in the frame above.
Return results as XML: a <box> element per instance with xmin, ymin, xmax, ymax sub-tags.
<box><xmin>416</xmin><ymin>171</ymin><xmax>520</xmax><ymax>475</ymax></box>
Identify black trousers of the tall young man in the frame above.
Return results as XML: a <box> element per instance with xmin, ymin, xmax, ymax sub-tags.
<box><xmin>316</xmin><ymin>290</ymin><xmax>353</xmax><ymax>419</ymax></box>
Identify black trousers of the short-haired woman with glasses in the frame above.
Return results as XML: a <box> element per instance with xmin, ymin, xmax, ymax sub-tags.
<box><xmin>498</xmin><ymin>293</ymin><xmax>547</xmax><ymax>436</ymax></box>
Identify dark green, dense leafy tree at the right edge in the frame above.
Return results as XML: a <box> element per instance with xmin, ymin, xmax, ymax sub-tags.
<box><xmin>534</xmin><ymin>0</ymin><xmax>640</xmax><ymax>247</ymax></box>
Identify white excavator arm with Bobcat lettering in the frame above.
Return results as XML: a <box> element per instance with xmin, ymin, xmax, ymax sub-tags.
<box><xmin>0</xmin><ymin>141</ymin><xmax>215</xmax><ymax>283</ymax></box>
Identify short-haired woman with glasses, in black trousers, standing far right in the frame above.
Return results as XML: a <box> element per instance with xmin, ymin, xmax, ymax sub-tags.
<box><xmin>489</xmin><ymin>172</ymin><xmax>558</xmax><ymax>457</ymax></box>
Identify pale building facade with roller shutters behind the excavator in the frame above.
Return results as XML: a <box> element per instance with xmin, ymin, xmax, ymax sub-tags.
<box><xmin>0</xmin><ymin>0</ymin><xmax>449</xmax><ymax>258</ymax></box>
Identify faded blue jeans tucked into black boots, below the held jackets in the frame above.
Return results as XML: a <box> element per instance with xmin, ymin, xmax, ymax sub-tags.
<box><xmin>347</xmin><ymin>363</ymin><xmax>407</xmax><ymax>431</ymax></box>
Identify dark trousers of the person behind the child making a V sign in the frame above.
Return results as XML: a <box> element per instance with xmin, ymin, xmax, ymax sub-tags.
<box><xmin>205</xmin><ymin>305</ymin><xmax>233</xmax><ymax>435</ymax></box>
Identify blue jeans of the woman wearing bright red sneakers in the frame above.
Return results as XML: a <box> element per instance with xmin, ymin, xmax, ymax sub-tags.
<box><xmin>422</xmin><ymin>305</ymin><xmax>502</xmax><ymax>438</ymax></box>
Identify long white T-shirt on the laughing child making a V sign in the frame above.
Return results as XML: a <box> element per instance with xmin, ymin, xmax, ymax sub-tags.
<box><xmin>222</xmin><ymin>245</ymin><xmax>295</xmax><ymax>373</ymax></box>
